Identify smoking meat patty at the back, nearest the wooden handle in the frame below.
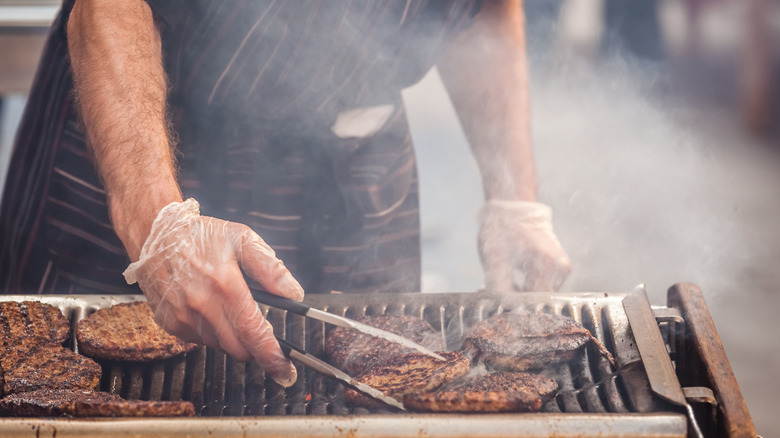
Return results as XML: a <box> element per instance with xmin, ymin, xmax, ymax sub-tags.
<box><xmin>463</xmin><ymin>312</ymin><xmax>614</xmax><ymax>371</ymax></box>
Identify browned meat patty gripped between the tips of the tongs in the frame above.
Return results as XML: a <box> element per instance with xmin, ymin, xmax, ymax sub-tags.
<box><xmin>344</xmin><ymin>352</ymin><xmax>470</xmax><ymax>407</ymax></box>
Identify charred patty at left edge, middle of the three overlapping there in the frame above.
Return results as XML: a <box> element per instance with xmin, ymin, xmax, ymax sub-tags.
<box><xmin>0</xmin><ymin>336</ymin><xmax>101</xmax><ymax>395</ymax></box>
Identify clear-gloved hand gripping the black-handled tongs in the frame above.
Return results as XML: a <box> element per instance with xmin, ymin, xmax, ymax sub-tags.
<box><xmin>124</xmin><ymin>199</ymin><xmax>303</xmax><ymax>386</ymax></box>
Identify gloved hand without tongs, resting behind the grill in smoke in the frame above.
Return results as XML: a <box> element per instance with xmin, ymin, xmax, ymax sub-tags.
<box><xmin>479</xmin><ymin>200</ymin><xmax>571</xmax><ymax>291</ymax></box>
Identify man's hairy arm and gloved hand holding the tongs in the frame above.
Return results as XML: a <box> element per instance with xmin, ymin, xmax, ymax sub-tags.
<box><xmin>68</xmin><ymin>0</ymin><xmax>303</xmax><ymax>385</ymax></box>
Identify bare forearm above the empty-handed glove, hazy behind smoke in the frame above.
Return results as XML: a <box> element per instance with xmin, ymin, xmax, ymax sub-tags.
<box><xmin>439</xmin><ymin>0</ymin><xmax>537</xmax><ymax>201</ymax></box>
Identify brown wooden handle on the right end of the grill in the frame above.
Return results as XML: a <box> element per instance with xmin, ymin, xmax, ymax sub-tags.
<box><xmin>666</xmin><ymin>283</ymin><xmax>758</xmax><ymax>438</ymax></box>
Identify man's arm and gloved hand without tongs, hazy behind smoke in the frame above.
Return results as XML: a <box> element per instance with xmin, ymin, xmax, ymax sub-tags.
<box><xmin>439</xmin><ymin>0</ymin><xmax>571</xmax><ymax>291</ymax></box>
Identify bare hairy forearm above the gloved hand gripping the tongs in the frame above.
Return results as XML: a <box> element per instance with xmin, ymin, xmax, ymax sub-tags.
<box><xmin>68</xmin><ymin>0</ymin><xmax>181</xmax><ymax>260</ymax></box>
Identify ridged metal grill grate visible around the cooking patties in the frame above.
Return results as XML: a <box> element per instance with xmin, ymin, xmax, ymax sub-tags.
<box><xmin>4</xmin><ymin>294</ymin><xmax>663</xmax><ymax>417</ymax></box>
